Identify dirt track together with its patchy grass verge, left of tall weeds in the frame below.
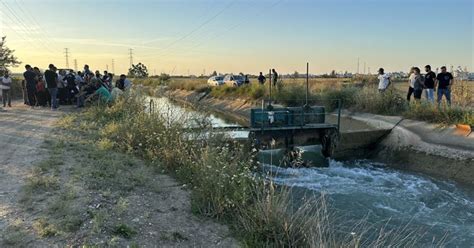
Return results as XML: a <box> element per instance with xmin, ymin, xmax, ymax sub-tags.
<box><xmin>0</xmin><ymin>103</ymin><xmax>238</xmax><ymax>247</ymax></box>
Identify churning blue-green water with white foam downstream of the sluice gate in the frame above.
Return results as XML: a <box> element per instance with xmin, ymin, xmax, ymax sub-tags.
<box><xmin>263</xmin><ymin>160</ymin><xmax>474</xmax><ymax>247</ymax></box>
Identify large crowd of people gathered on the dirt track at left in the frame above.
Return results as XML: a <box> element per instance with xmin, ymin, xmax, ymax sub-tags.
<box><xmin>16</xmin><ymin>64</ymin><xmax>132</xmax><ymax>110</ymax></box>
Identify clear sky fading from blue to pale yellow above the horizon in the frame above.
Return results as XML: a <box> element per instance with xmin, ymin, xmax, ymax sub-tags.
<box><xmin>0</xmin><ymin>0</ymin><xmax>474</xmax><ymax>75</ymax></box>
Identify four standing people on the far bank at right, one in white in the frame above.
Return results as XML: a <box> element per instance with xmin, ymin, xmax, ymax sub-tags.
<box><xmin>378</xmin><ymin>65</ymin><xmax>454</xmax><ymax>106</ymax></box>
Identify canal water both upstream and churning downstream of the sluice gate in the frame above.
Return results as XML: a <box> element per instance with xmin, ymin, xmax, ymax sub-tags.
<box><xmin>151</xmin><ymin>98</ymin><xmax>474</xmax><ymax>247</ymax></box>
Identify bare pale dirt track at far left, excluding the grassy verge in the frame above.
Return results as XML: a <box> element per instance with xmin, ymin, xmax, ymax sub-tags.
<box><xmin>0</xmin><ymin>102</ymin><xmax>68</xmax><ymax>236</ymax></box>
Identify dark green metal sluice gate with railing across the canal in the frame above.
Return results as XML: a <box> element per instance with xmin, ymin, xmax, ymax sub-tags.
<box><xmin>249</xmin><ymin>100</ymin><xmax>340</xmax><ymax>157</ymax></box>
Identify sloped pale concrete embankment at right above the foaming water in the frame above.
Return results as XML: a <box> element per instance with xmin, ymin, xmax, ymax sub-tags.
<box><xmin>350</xmin><ymin>113</ymin><xmax>474</xmax><ymax>185</ymax></box>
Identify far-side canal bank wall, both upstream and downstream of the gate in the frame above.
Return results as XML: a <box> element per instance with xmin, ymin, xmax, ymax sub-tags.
<box><xmin>166</xmin><ymin>91</ymin><xmax>474</xmax><ymax>185</ymax></box>
